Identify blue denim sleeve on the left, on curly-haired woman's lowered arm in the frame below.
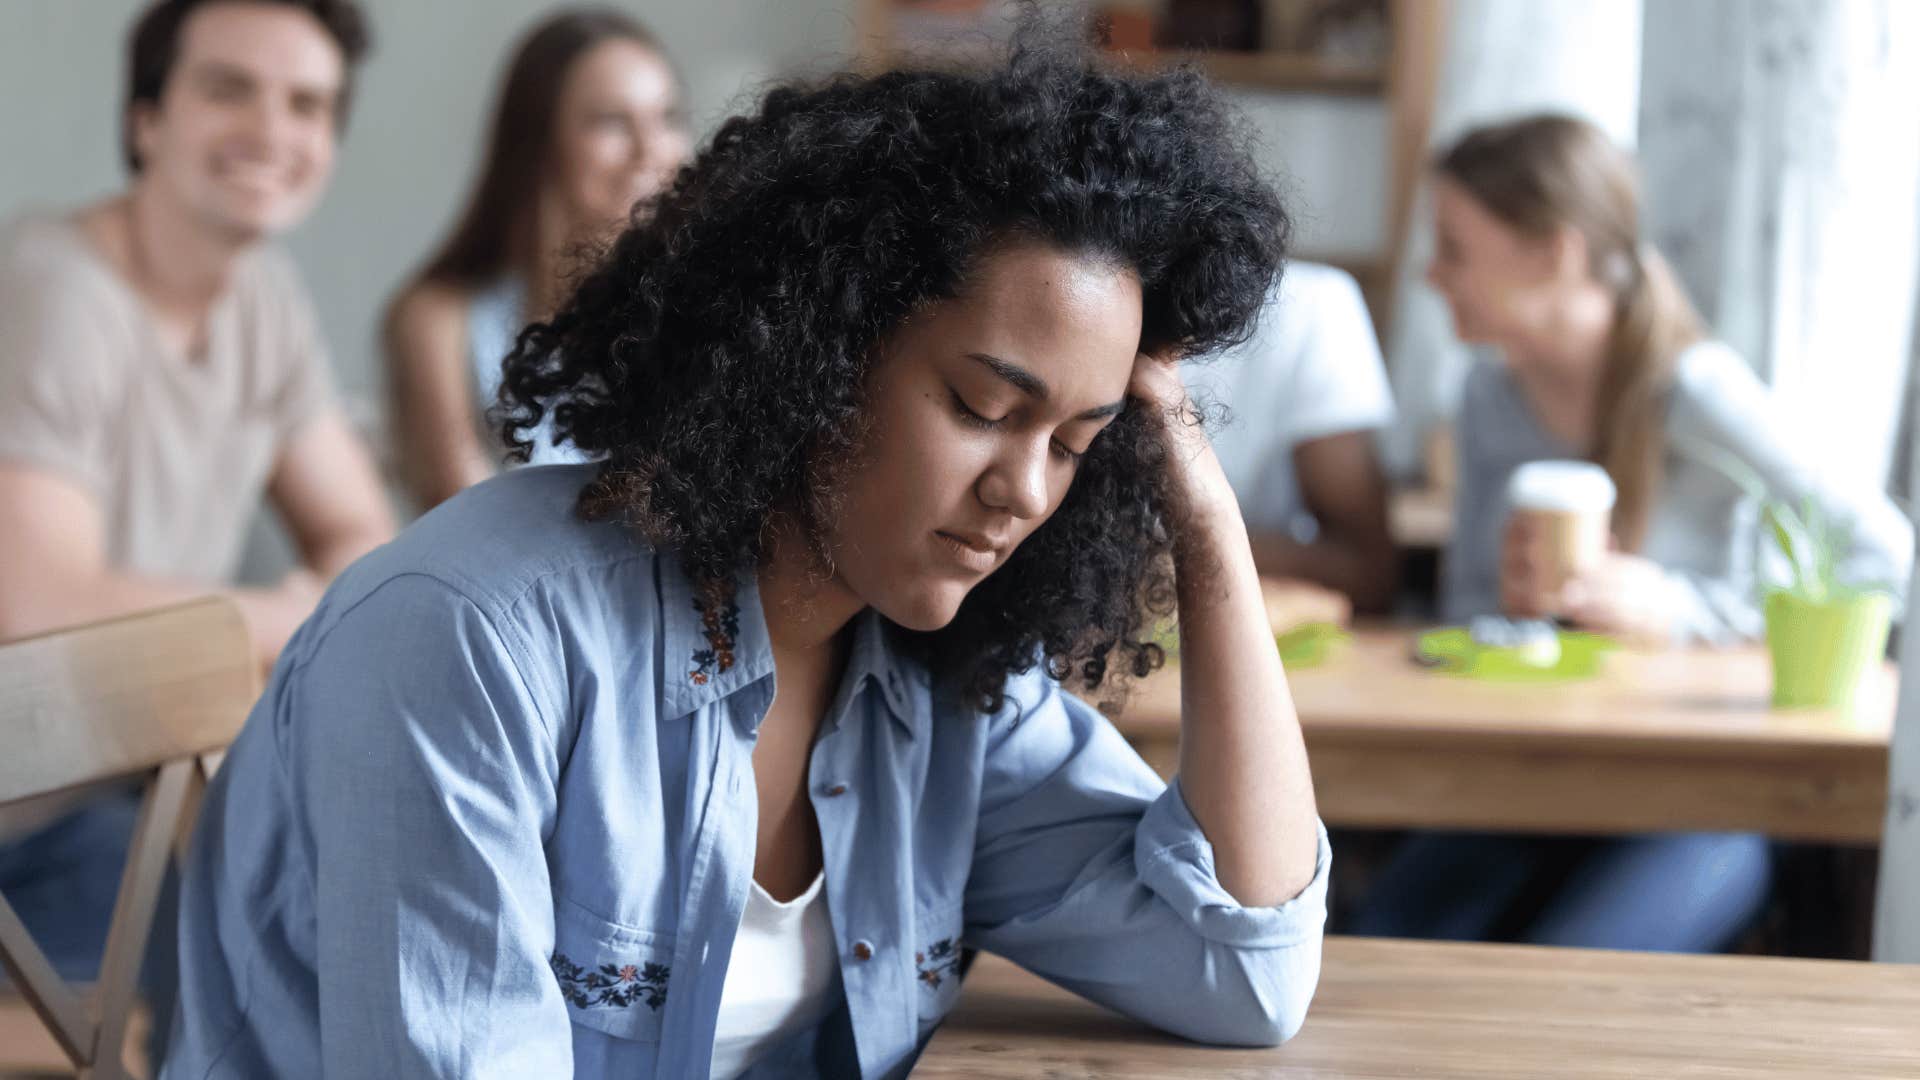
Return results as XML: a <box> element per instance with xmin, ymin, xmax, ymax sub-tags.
<box><xmin>280</xmin><ymin>575</ymin><xmax>572</xmax><ymax>1078</ymax></box>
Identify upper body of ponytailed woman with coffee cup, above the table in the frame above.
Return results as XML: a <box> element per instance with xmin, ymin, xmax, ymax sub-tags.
<box><xmin>1428</xmin><ymin>115</ymin><xmax>1912</xmax><ymax>644</ymax></box>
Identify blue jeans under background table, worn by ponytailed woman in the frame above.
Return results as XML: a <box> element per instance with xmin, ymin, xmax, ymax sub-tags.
<box><xmin>1350</xmin><ymin>832</ymin><xmax>1772</xmax><ymax>953</ymax></box>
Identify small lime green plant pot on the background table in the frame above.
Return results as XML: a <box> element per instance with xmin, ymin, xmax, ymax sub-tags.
<box><xmin>1766</xmin><ymin>592</ymin><xmax>1893</xmax><ymax>709</ymax></box>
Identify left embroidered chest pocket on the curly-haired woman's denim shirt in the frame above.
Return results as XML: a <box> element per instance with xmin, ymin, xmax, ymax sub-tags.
<box><xmin>549</xmin><ymin>899</ymin><xmax>674</xmax><ymax>1042</ymax></box>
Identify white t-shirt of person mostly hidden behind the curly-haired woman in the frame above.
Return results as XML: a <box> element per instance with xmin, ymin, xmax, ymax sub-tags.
<box><xmin>1183</xmin><ymin>255</ymin><xmax>1394</xmax><ymax>540</ymax></box>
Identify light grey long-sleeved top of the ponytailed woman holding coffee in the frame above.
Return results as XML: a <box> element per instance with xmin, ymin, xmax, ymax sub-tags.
<box><xmin>1440</xmin><ymin>342</ymin><xmax>1914</xmax><ymax>644</ymax></box>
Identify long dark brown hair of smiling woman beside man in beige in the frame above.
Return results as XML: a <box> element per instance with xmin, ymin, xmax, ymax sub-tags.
<box><xmin>420</xmin><ymin>8</ymin><xmax>670</xmax><ymax>288</ymax></box>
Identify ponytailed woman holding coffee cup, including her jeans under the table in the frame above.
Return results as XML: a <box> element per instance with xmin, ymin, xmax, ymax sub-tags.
<box><xmin>1354</xmin><ymin>115</ymin><xmax>1912</xmax><ymax>951</ymax></box>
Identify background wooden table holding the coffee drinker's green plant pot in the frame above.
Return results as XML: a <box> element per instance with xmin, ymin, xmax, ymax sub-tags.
<box><xmin>1108</xmin><ymin>626</ymin><xmax>1897</xmax><ymax>844</ymax></box>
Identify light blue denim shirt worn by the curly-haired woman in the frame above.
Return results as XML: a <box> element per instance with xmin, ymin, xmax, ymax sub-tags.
<box><xmin>163</xmin><ymin>465</ymin><xmax>1329</xmax><ymax>1080</ymax></box>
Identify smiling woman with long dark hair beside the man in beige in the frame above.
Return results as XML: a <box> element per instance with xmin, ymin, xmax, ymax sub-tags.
<box><xmin>384</xmin><ymin>8</ymin><xmax>689</xmax><ymax>507</ymax></box>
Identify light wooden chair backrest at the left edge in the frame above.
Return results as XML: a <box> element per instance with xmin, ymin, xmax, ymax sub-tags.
<box><xmin>0</xmin><ymin>598</ymin><xmax>257</xmax><ymax>1078</ymax></box>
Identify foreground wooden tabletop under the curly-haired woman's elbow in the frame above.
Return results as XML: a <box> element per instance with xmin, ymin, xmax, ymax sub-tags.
<box><xmin>914</xmin><ymin>938</ymin><xmax>1920</xmax><ymax>1080</ymax></box>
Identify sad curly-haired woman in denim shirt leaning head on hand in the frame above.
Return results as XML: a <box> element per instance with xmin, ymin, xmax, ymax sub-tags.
<box><xmin>167</xmin><ymin>27</ymin><xmax>1329</xmax><ymax>1078</ymax></box>
